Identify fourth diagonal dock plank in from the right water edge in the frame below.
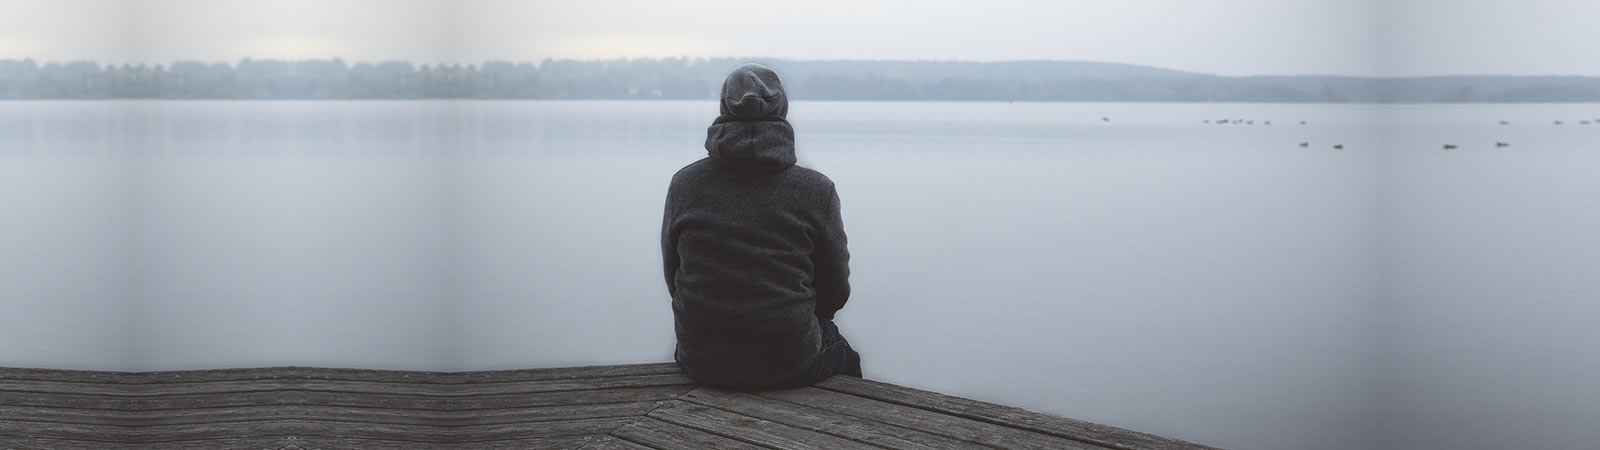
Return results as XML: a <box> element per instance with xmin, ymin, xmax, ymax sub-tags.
<box><xmin>646</xmin><ymin>400</ymin><xmax>877</xmax><ymax>450</ymax></box>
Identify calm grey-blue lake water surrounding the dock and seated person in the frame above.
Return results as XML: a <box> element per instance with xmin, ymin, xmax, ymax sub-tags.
<box><xmin>0</xmin><ymin>101</ymin><xmax>1600</xmax><ymax>450</ymax></box>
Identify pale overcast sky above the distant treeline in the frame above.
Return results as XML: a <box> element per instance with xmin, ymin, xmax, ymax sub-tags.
<box><xmin>0</xmin><ymin>0</ymin><xmax>1600</xmax><ymax>75</ymax></box>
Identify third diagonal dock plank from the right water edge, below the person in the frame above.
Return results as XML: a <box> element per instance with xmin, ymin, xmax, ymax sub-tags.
<box><xmin>682</xmin><ymin>388</ymin><xmax>995</xmax><ymax>450</ymax></box>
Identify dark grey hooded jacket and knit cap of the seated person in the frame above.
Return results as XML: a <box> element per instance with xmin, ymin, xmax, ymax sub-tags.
<box><xmin>661</xmin><ymin>64</ymin><xmax>850</xmax><ymax>389</ymax></box>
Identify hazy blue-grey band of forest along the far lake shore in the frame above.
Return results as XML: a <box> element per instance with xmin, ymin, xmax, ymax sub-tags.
<box><xmin>0</xmin><ymin>58</ymin><xmax>1600</xmax><ymax>102</ymax></box>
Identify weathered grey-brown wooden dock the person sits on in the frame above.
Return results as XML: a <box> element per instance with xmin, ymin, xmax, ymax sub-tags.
<box><xmin>0</xmin><ymin>364</ymin><xmax>1214</xmax><ymax>450</ymax></box>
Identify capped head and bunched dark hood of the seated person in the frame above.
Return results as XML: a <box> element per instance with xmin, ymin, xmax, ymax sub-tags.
<box><xmin>706</xmin><ymin>64</ymin><xmax>795</xmax><ymax>173</ymax></box>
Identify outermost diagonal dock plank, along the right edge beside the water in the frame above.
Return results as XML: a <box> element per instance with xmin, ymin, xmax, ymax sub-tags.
<box><xmin>816</xmin><ymin>376</ymin><xmax>1218</xmax><ymax>450</ymax></box>
